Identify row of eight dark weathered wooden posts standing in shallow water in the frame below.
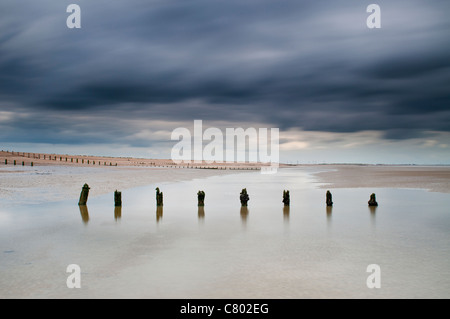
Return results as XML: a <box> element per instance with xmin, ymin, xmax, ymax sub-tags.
<box><xmin>78</xmin><ymin>184</ymin><xmax>378</xmax><ymax>207</ymax></box>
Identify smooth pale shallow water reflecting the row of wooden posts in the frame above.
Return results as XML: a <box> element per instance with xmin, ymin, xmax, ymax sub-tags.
<box><xmin>0</xmin><ymin>168</ymin><xmax>450</xmax><ymax>298</ymax></box>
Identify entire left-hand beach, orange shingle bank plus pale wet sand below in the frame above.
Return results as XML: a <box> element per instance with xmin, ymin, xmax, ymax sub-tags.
<box><xmin>0</xmin><ymin>151</ymin><xmax>261</xmax><ymax>203</ymax></box>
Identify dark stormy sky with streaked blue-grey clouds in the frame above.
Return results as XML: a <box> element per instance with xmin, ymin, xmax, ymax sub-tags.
<box><xmin>0</xmin><ymin>0</ymin><xmax>450</xmax><ymax>164</ymax></box>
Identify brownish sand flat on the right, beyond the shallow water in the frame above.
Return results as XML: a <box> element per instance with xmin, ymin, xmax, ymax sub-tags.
<box><xmin>314</xmin><ymin>165</ymin><xmax>450</xmax><ymax>193</ymax></box>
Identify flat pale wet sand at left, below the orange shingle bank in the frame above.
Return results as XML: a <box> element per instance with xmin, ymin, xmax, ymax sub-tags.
<box><xmin>0</xmin><ymin>165</ymin><xmax>250</xmax><ymax>204</ymax></box>
